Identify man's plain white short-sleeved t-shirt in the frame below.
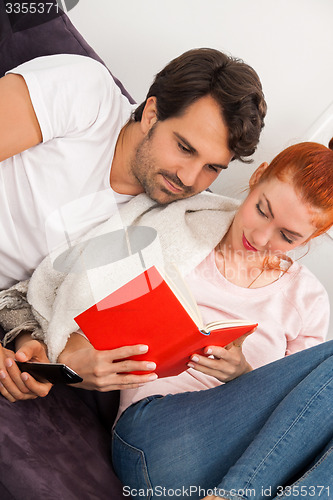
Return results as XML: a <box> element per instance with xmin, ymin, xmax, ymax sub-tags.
<box><xmin>0</xmin><ymin>55</ymin><xmax>134</xmax><ymax>289</ymax></box>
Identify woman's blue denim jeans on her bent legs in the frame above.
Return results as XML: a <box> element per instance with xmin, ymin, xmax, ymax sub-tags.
<box><xmin>113</xmin><ymin>341</ymin><xmax>333</xmax><ymax>500</ymax></box>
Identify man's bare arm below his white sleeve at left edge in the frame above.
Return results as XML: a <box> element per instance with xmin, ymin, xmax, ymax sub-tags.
<box><xmin>0</xmin><ymin>74</ymin><xmax>42</xmax><ymax>161</ymax></box>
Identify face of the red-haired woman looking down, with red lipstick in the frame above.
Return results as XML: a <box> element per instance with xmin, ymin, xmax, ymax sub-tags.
<box><xmin>225</xmin><ymin>178</ymin><xmax>317</xmax><ymax>256</ymax></box>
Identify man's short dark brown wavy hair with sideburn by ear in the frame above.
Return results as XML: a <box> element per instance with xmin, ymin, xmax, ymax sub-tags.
<box><xmin>134</xmin><ymin>48</ymin><xmax>267</xmax><ymax>163</ymax></box>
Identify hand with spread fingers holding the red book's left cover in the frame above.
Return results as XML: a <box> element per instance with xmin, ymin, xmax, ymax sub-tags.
<box><xmin>58</xmin><ymin>333</ymin><xmax>157</xmax><ymax>392</ymax></box>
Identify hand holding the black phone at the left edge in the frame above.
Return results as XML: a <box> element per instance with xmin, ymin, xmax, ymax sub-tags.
<box><xmin>0</xmin><ymin>334</ymin><xmax>52</xmax><ymax>403</ymax></box>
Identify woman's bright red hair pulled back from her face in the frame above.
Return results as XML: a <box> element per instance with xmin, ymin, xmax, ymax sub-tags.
<box><xmin>254</xmin><ymin>138</ymin><xmax>333</xmax><ymax>238</ymax></box>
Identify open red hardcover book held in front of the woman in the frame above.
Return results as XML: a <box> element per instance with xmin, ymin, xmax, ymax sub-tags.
<box><xmin>75</xmin><ymin>266</ymin><xmax>257</xmax><ymax>377</ymax></box>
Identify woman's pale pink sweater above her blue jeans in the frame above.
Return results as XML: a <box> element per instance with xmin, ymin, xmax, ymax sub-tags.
<box><xmin>118</xmin><ymin>251</ymin><xmax>329</xmax><ymax>415</ymax></box>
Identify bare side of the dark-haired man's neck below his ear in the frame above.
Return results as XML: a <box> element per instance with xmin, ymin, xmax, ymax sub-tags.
<box><xmin>110</xmin><ymin>121</ymin><xmax>144</xmax><ymax>195</ymax></box>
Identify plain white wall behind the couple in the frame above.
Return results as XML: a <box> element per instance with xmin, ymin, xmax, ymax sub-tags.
<box><xmin>69</xmin><ymin>0</ymin><xmax>333</xmax><ymax>338</ymax></box>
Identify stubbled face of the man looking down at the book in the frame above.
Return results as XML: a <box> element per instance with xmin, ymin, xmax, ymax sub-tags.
<box><xmin>131</xmin><ymin>96</ymin><xmax>233</xmax><ymax>204</ymax></box>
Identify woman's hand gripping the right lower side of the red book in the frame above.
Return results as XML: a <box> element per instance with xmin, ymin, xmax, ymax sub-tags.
<box><xmin>188</xmin><ymin>336</ymin><xmax>252</xmax><ymax>382</ymax></box>
